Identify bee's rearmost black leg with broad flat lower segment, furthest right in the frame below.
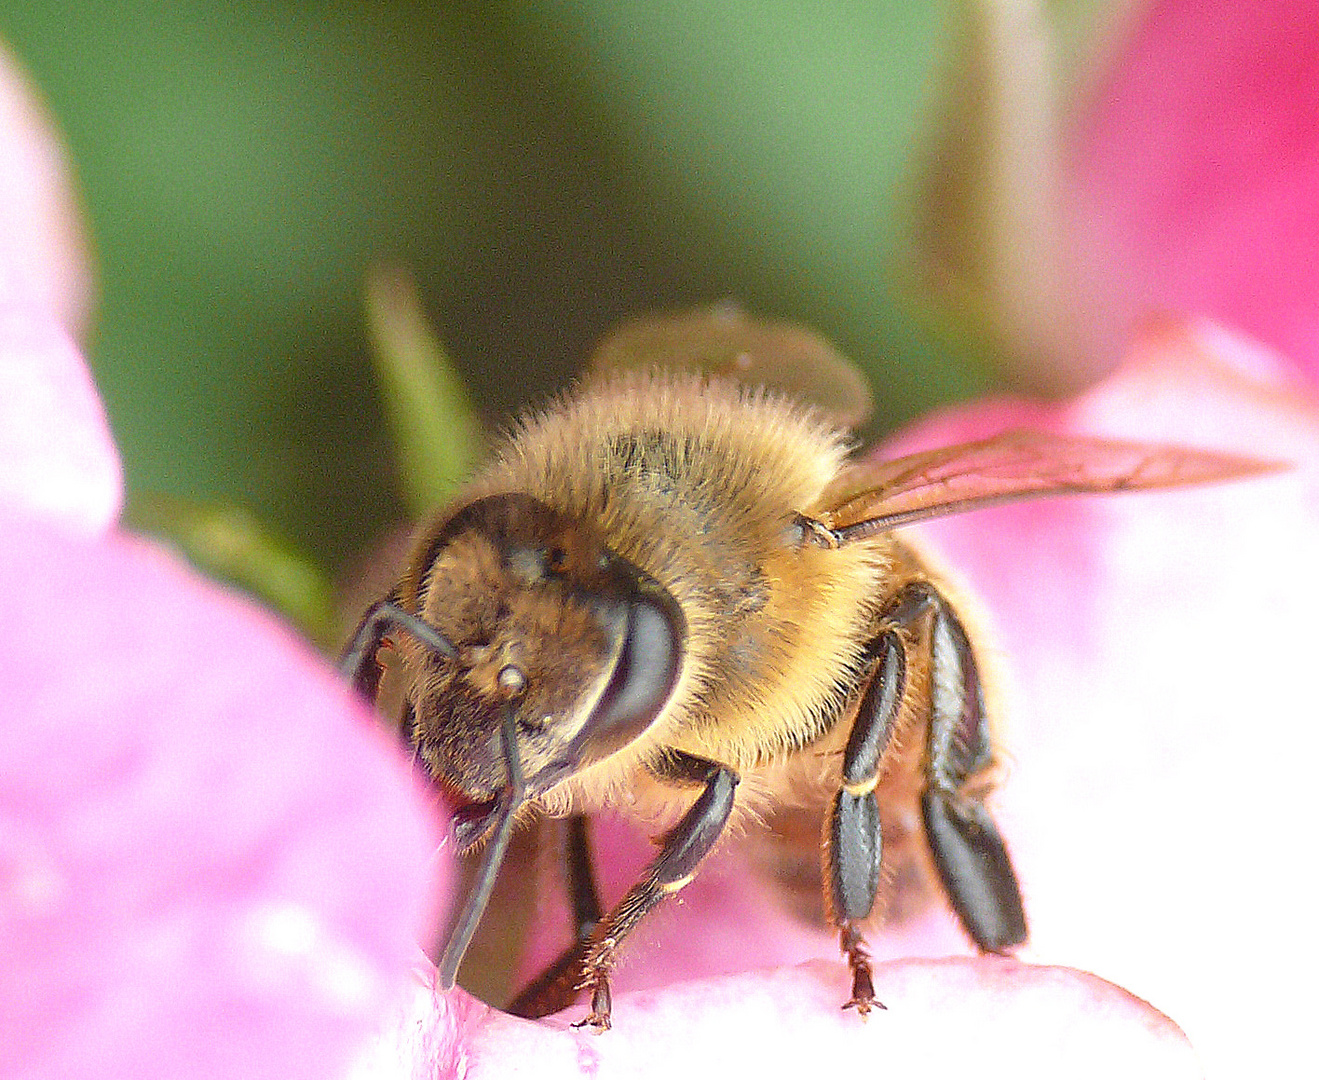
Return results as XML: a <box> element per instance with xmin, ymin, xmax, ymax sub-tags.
<box><xmin>894</xmin><ymin>582</ymin><xmax>1026</xmax><ymax>952</ymax></box>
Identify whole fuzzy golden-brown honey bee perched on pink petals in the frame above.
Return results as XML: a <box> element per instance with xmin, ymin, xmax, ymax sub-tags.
<box><xmin>343</xmin><ymin>307</ymin><xmax>1272</xmax><ymax>1031</ymax></box>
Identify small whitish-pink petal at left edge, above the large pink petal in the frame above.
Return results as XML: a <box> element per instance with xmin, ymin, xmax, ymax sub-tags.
<box><xmin>0</xmin><ymin>301</ymin><xmax>123</xmax><ymax>534</ymax></box>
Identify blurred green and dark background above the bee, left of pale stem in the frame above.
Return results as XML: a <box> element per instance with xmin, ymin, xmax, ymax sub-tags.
<box><xmin>0</xmin><ymin>0</ymin><xmax>1023</xmax><ymax>567</ymax></box>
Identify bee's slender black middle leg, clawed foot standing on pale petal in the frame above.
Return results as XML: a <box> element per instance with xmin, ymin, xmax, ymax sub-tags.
<box><xmin>824</xmin><ymin>630</ymin><xmax>906</xmax><ymax>1017</ymax></box>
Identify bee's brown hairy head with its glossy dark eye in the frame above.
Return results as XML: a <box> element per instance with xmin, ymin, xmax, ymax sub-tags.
<box><xmin>398</xmin><ymin>493</ymin><xmax>686</xmax><ymax>845</ymax></box>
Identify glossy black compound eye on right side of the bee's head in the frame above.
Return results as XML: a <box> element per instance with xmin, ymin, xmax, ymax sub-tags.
<box><xmin>580</xmin><ymin>597</ymin><xmax>682</xmax><ymax>764</ymax></box>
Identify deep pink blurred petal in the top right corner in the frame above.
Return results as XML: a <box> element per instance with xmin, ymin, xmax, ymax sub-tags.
<box><xmin>1070</xmin><ymin>0</ymin><xmax>1319</xmax><ymax>378</ymax></box>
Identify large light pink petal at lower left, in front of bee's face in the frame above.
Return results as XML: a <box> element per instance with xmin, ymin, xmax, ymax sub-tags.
<box><xmin>0</xmin><ymin>521</ymin><xmax>437</xmax><ymax>1077</ymax></box>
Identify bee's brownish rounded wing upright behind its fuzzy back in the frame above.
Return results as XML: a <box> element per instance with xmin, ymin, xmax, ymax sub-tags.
<box><xmin>587</xmin><ymin>302</ymin><xmax>873</xmax><ymax>429</ymax></box>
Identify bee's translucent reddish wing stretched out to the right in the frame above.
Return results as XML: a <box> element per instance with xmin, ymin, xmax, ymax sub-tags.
<box><xmin>819</xmin><ymin>431</ymin><xmax>1286</xmax><ymax>542</ymax></box>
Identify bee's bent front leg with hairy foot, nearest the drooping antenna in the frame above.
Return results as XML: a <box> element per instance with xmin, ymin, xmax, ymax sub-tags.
<box><xmin>574</xmin><ymin>754</ymin><xmax>739</xmax><ymax>1031</ymax></box>
